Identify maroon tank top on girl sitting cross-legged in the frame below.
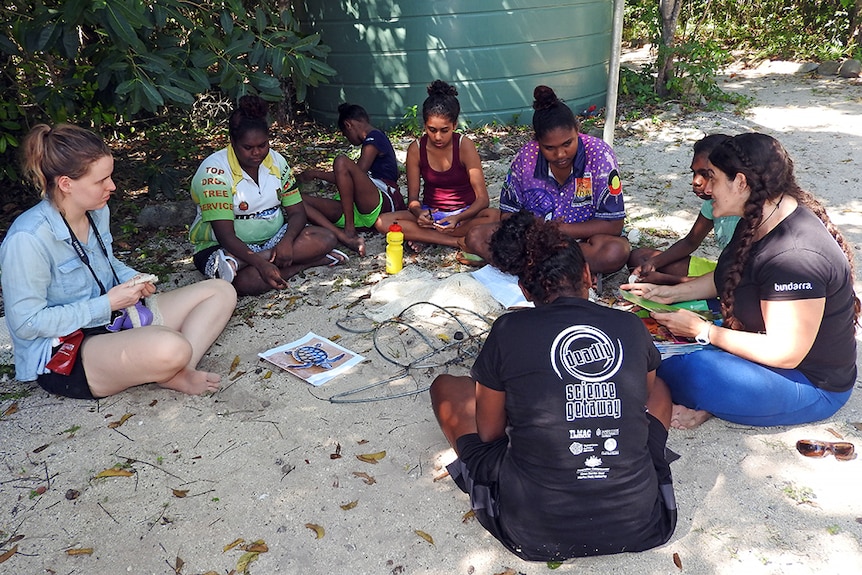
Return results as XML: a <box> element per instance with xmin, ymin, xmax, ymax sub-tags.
<box><xmin>419</xmin><ymin>132</ymin><xmax>476</xmax><ymax>212</ymax></box>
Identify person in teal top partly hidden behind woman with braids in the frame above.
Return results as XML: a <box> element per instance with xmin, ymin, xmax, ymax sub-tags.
<box><xmin>628</xmin><ymin>134</ymin><xmax>739</xmax><ymax>284</ymax></box>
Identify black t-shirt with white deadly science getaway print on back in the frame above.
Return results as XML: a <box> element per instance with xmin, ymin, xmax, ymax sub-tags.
<box><xmin>472</xmin><ymin>298</ymin><xmax>661</xmax><ymax>557</ymax></box>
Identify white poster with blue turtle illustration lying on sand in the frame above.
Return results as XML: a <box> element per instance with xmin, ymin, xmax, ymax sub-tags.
<box><xmin>258</xmin><ymin>332</ymin><xmax>365</xmax><ymax>386</ymax></box>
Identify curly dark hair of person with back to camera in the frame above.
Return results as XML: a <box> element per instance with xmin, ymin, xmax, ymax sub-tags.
<box><xmin>491</xmin><ymin>210</ymin><xmax>586</xmax><ymax>303</ymax></box>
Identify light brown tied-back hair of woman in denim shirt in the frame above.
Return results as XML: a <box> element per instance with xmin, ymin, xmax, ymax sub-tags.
<box><xmin>21</xmin><ymin>124</ymin><xmax>111</xmax><ymax>200</ymax></box>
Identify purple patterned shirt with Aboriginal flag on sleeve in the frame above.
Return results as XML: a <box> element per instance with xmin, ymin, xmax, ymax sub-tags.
<box><xmin>500</xmin><ymin>134</ymin><xmax>626</xmax><ymax>224</ymax></box>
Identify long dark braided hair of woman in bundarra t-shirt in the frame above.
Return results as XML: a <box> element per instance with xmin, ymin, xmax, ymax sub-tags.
<box><xmin>709</xmin><ymin>132</ymin><xmax>860</xmax><ymax>329</ymax></box>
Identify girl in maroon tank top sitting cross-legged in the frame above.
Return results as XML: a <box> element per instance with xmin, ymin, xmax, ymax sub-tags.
<box><xmin>377</xmin><ymin>80</ymin><xmax>497</xmax><ymax>252</ymax></box>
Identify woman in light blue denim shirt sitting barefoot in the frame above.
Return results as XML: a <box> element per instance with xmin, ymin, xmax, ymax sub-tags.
<box><xmin>0</xmin><ymin>124</ymin><xmax>236</xmax><ymax>399</ymax></box>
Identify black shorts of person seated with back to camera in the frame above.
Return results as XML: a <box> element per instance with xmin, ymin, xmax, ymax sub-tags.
<box><xmin>446</xmin><ymin>413</ymin><xmax>677</xmax><ymax>561</ymax></box>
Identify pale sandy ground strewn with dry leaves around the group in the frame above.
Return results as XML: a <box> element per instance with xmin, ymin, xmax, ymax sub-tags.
<box><xmin>5</xmin><ymin>59</ymin><xmax>862</xmax><ymax>575</ymax></box>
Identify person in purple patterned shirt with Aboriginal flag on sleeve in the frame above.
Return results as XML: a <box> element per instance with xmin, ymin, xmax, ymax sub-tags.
<box><xmin>461</xmin><ymin>86</ymin><xmax>631</xmax><ymax>273</ymax></box>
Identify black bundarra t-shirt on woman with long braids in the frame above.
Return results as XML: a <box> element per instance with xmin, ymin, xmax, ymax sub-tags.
<box><xmin>715</xmin><ymin>205</ymin><xmax>856</xmax><ymax>392</ymax></box>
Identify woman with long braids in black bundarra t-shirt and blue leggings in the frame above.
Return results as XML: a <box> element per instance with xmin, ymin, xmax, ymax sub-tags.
<box><xmin>622</xmin><ymin>133</ymin><xmax>859</xmax><ymax>428</ymax></box>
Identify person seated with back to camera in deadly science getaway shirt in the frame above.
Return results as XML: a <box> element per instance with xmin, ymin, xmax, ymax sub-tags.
<box><xmin>431</xmin><ymin>211</ymin><xmax>677</xmax><ymax>561</ymax></box>
